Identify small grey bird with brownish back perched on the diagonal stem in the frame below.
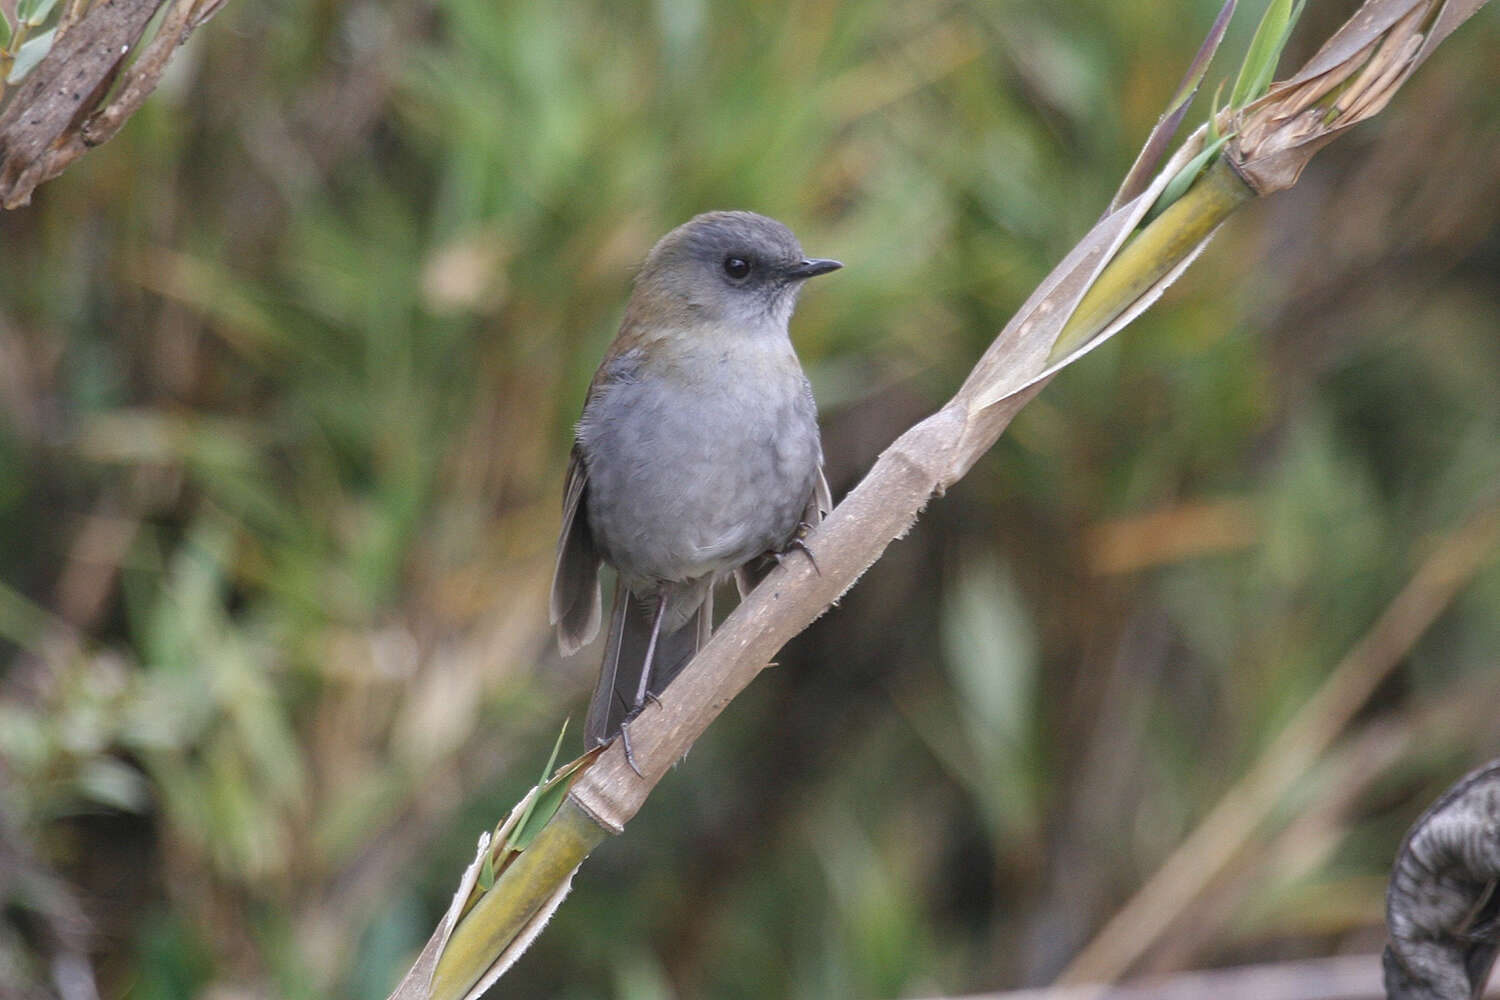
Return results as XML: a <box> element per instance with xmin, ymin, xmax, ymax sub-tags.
<box><xmin>551</xmin><ymin>211</ymin><xmax>842</xmax><ymax>753</ymax></box>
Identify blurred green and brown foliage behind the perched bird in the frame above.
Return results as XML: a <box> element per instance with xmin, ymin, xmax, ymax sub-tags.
<box><xmin>0</xmin><ymin>0</ymin><xmax>1500</xmax><ymax>1000</ymax></box>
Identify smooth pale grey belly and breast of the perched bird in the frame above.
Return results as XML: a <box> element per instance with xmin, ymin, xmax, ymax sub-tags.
<box><xmin>579</xmin><ymin>382</ymin><xmax>822</xmax><ymax>594</ymax></box>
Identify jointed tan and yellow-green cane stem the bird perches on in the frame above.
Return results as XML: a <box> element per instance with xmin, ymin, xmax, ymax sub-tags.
<box><xmin>392</xmin><ymin>0</ymin><xmax>1484</xmax><ymax>1000</ymax></box>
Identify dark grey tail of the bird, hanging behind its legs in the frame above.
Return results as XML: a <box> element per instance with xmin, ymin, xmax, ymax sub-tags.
<box><xmin>584</xmin><ymin>580</ymin><xmax>714</xmax><ymax>748</ymax></box>
